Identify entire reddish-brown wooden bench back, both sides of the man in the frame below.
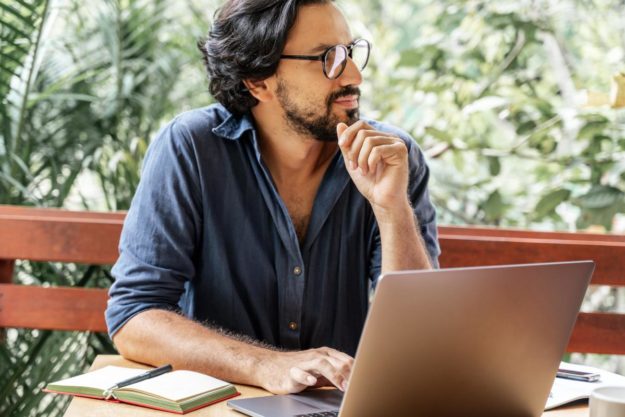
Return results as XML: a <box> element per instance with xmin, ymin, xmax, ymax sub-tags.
<box><xmin>0</xmin><ymin>206</ymin><xmax>625</xmax><ymax>354</ymax></box>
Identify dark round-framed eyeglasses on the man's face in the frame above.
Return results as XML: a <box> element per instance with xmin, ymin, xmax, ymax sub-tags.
<box><xmin>280</xmin><ymin>39</ymin><xmax>371</xmax><ymax>80</ymax></box>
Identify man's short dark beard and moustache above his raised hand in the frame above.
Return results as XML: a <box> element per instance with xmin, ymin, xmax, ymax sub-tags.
<box><xmin>276</xmin><ymin>80</ymin><xmax>360</xmax><ymax>142</ymax></box>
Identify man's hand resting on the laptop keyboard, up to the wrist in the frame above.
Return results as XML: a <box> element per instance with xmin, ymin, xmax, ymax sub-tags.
<box><xmin>258</xmin><ymin>347</ymin><xmax>354</xmax><ymax>394</ymax></box>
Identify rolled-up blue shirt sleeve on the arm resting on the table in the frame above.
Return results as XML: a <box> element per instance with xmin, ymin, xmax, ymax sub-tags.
<box><xmin>105</xmin><ymin>120</ymin><xmax>201</xmax><ymax>337</ymax></box>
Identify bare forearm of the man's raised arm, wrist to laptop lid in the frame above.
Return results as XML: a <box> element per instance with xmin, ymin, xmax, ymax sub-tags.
<box><xmin>374</xmin><ymin>200</ymin><xmax>432</xmax><ymax>273</ymax></box>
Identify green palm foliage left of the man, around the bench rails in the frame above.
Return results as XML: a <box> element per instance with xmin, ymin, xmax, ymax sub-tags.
<box><xmin>0</xmin><ymin>0</ymin><xmax>208</xmax><ymax>416</ymax></box>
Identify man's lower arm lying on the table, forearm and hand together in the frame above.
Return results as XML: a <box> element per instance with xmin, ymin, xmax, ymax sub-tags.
<box><xmin>113</xmin><ymin>310</ymin><xmax>353</xmax><ymax>394</ymax></box>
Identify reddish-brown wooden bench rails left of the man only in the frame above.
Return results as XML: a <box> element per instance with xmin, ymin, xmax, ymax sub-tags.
<box><xmin>0</xmin><ymin>206</ymin><xmax>125</xmax><ymax>332</ymax></box>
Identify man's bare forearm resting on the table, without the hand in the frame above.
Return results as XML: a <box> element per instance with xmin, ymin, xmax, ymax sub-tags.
<box><xmin>113</xmin><ymin>310</ymin><xmax>269</xmax><ymax>385</ymax></box>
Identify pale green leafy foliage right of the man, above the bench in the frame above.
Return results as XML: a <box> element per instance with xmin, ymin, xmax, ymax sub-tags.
<box><xmin>345</xmin><ymin>0</ymin><xmax>625</xmax><ymax>230</ymax></box>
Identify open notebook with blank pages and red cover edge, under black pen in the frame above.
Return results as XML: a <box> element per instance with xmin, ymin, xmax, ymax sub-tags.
<box><xmin>44</xmin><ymin>366</ymin><xmax>239</xmax><ymax>414</ymax></box>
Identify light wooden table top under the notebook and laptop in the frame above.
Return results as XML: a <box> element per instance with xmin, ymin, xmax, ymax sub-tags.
<box><xmin>61</xmin><ymin>355</ymin><xmax>588</xmax><ymax>417</ymax></box>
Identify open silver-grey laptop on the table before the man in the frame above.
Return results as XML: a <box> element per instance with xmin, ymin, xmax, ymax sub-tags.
<box><xmin>228</xmin><ymin>261</ymin><xmax>594</xmax><ymax>417</ymax></box>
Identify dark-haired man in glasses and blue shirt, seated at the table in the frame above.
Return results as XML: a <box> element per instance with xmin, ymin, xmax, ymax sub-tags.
<box><xmin>106</xmin><ymin>0</ymin><xmax>439</xmax><ymax>393</ymax></box>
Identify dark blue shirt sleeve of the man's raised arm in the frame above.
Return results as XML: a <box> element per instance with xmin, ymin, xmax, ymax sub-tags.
<box><xmin>369</xmin><ymin>124</ymin><xmax>441</xmax><ymax>287</ymax></box>
